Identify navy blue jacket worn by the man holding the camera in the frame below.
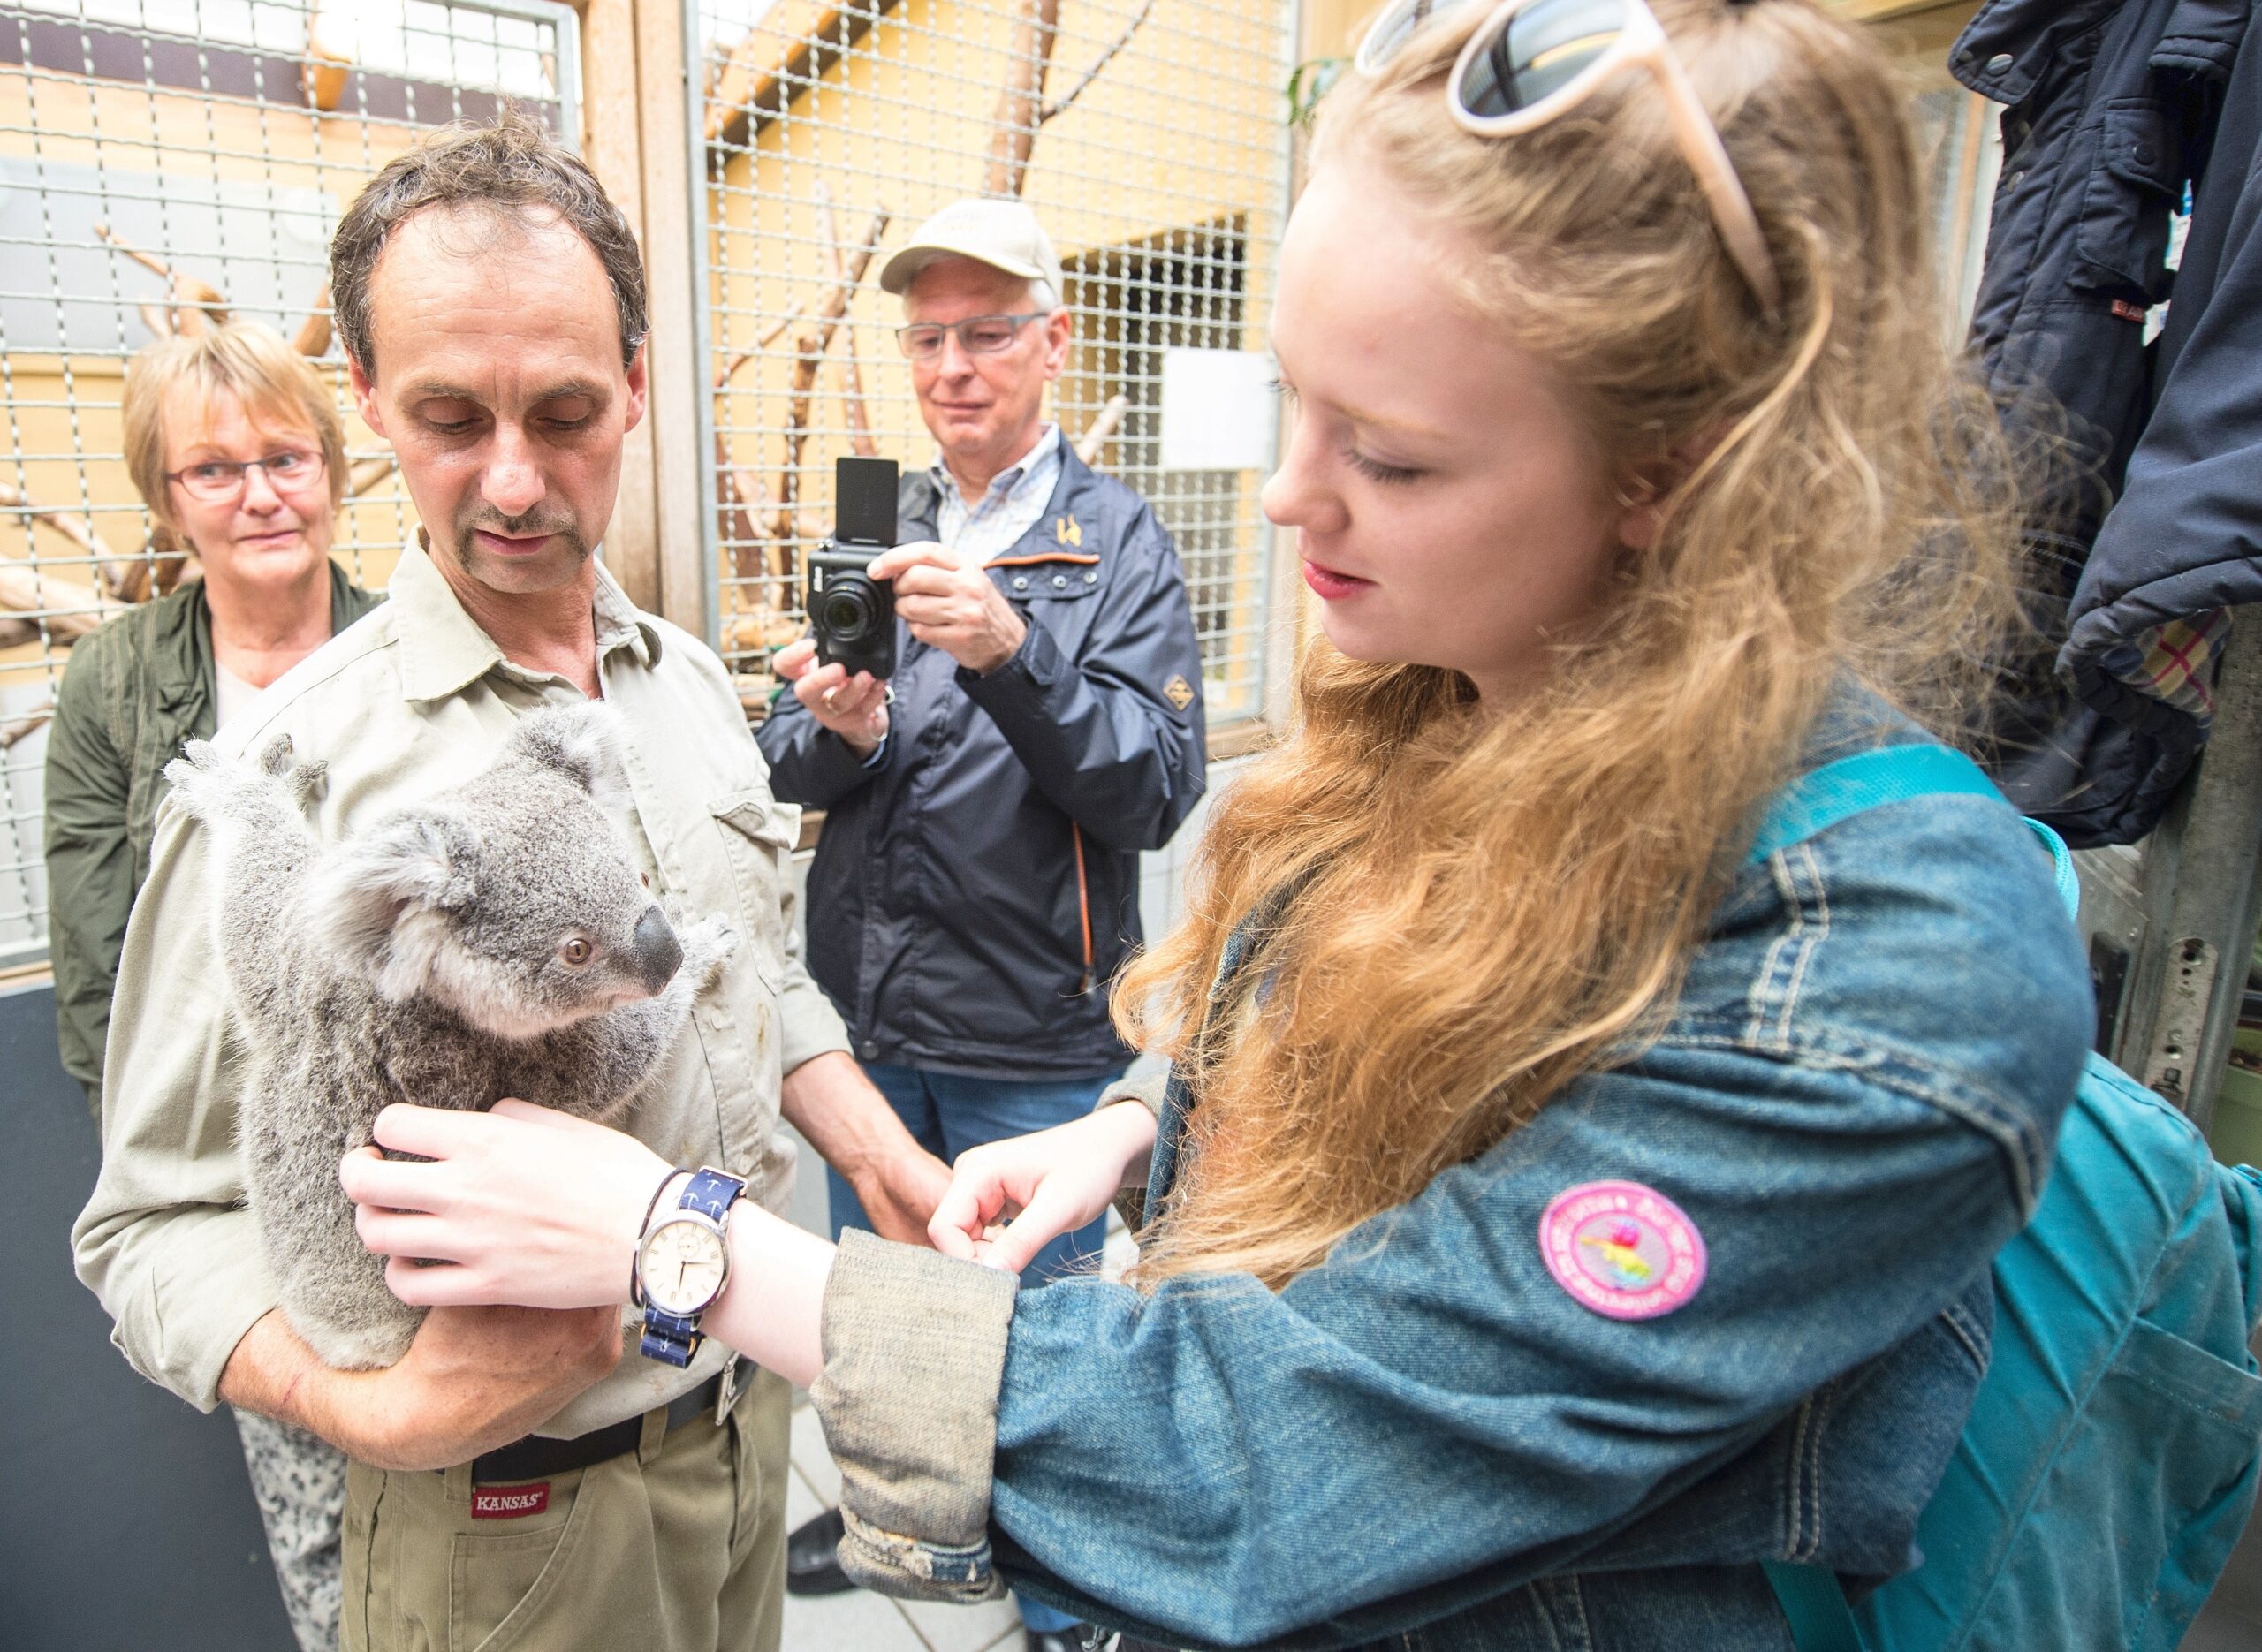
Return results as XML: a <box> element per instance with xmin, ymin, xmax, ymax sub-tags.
<box><xmin>755</xmin><ymin>451</ymin><xmax>1205</xmax><ymax>1080</ymax></box>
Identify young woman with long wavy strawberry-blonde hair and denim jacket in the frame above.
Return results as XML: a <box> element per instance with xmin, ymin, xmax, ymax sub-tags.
<box><xmin>330</xmin><ymin>0</ymin><xmax>2090</xmax><ymax>1652</ymax></box>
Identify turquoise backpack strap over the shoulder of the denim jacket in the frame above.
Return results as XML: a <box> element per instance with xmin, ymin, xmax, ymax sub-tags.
<box><xmin>1750</xmin><ymin>745</ymin><xmax>2081</xmax><ymax>1652</ymax></box>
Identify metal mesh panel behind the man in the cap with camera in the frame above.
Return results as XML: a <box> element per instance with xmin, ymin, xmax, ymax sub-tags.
<box><xmin>692</xmin><ymin>0</ymin><xmax>1294</xmax><ymax>722</ymax></box>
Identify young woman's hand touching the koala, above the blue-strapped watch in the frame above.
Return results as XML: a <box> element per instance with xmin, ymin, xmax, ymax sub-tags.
<box><xmin>337</xmin><ymin>1100</ymin><xmax>672</xmax><ymax>1308</ymax></box>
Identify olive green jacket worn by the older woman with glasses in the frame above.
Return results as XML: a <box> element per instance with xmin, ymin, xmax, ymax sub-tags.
<box><xmin>48</xmin><ymin>561</ymin><xmax>384</xmax><ymax>1116</ymax></box>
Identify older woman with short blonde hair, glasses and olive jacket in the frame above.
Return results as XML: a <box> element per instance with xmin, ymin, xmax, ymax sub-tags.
<box><xmin>48</xmin><ymin>312</ymin><xmax>380</xmax><ymax>1649</ymax></box>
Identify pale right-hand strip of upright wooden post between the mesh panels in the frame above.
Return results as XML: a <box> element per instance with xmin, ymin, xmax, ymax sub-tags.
<box><xmin>635</xmin><ymin>0</ymin><xmax>717</xmax><ymax>638</ymax></box>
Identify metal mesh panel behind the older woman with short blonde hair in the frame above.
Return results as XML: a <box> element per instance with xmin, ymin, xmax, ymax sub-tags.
<box><xmin>0</xmin><ymin>0</ymin><xmax>579</xmax><ymax>964</ymax></box>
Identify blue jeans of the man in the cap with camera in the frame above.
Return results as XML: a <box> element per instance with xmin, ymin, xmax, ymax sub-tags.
<box><xmin>825</xmin><ymin>1061</ymin><xmax>1122</xmax><ymax>1634</ymax></box>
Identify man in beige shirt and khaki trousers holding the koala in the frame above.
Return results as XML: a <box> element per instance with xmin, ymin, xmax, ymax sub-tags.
<box><xmin>72</xmin><ymin>116</ymin><xmax>948</xmax><ymax>1652</ymax></box>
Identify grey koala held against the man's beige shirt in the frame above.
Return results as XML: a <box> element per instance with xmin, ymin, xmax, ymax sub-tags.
<box><xmin>165</xmin><ymin>706</ymin><xmax>738</xmax><ymax>1369</ymax></box>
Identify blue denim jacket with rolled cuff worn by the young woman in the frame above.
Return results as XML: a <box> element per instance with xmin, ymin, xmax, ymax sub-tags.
<box><xmin>815</xmin><ymin>710</ymin><xmax>2090</xmax><ymax>1652</ymax></box>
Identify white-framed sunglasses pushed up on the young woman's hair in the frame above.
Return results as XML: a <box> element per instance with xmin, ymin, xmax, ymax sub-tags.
<box><xmin>1357</xmin><ymin>0</ymin><xmax>1782</xmax><ymax>310</ymax></box>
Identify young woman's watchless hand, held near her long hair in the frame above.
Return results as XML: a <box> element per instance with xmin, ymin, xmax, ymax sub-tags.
<box><xmin>928</xmin><ymin>1103</ymin><xmax>1154</xmax><ymax>1274</ymax></box>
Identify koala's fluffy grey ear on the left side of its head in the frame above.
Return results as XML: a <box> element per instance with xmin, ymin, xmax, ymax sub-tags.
<box><xmin>306</xmin><ymin>808</ymin><xmax>477</xmax><ymax>998</ymax></box>
